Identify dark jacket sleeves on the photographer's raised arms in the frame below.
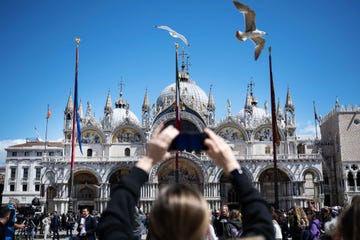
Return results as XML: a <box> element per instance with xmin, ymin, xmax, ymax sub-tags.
<box><xmin>98</xmin><ymin>167</ymin><xmax>275</xmax><ymax>240</ymax></box>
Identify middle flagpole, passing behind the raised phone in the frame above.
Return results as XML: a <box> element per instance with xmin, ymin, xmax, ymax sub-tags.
<box><xmin>175</xmin><ymin>43</ymin><xmax>181</xmax><ymax>183</ymax></box>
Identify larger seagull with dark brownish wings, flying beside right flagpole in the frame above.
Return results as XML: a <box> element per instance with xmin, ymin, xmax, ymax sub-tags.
<box><xmin>233</xmin><ymin>0</ymin><xmax>266</xmax><ymax>60</ymax></box>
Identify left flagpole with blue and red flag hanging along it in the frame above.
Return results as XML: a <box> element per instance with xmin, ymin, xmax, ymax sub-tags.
<box><xmin>69</xmin><ymin>38</ymin><xmax>80</xmax><ymax>212</ymax></box>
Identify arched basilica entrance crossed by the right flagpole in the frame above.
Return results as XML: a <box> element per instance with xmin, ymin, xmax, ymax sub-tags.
<box><xmin>259</xmin><ymin>168</ymin><xmax>292</xmax><ymax>209</ymax></box>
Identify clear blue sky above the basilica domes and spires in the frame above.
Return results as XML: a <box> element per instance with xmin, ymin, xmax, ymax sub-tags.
<box><xmin>0</xmin><ymin>0</ymin><xmax>360</xmax><ymax>161</ymax></box>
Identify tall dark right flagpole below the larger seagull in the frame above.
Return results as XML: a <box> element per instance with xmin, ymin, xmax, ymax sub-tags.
<box><xmin>269</xmin><ymin>47</ymin><xmax>279</xmax><ymax>209</ymax></box>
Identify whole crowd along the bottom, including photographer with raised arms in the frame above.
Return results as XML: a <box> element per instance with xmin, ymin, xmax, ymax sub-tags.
<box><xmin>0</xmin><ymin>125</ymin><xmax>360</xmax><ymax>240</ymax></box>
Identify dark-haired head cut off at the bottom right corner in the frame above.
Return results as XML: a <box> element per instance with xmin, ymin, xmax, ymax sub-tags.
<box><xmin>338</xmin><ymin>198</ymin><xmax>360</xmax><ymax>240</ymax></box>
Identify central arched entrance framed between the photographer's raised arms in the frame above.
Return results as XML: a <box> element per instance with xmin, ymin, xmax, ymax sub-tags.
<box><xmin>157</xmin><ymin>158</ymin><xmax>204</xmax><ymax>192</ymax></box>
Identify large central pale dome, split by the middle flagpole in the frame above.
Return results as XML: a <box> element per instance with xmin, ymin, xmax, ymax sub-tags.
<box><xmin>156</xmin><ymin>80</ymin><xmax>208</xmax><ymax>112</ymax></box>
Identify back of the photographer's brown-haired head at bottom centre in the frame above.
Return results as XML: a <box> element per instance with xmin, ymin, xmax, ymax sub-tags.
<box><xmin>149</xmin><ymin>184</ymin><xmax>210</xmax><ymax>240</ymax></box>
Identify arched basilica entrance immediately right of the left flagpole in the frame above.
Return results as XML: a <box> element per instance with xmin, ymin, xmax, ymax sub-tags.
<box><xmin>73</xmin><ymin>171</ymin><xmax>100</xmax><ymax>212</ymax></box>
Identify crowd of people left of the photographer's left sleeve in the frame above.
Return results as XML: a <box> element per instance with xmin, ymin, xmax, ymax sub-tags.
<box><xmin>0</xmin><ymin>199</ymin><xmax>100</xmax><ymax>240</ymax></box>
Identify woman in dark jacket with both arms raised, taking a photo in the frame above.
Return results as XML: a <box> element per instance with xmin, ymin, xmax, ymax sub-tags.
<box><xmin>98</xmin><ymin>125</ymin><xmax>274</xmax><ymax>240</ymax></box>
